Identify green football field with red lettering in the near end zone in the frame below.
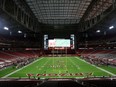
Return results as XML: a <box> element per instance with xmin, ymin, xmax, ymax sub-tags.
<box><xmin>1</xmin><ymin>57</ymin><xmax>116</xmax><ymax>78</ymax></box>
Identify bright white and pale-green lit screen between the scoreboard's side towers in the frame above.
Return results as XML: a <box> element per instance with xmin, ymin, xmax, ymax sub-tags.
<box><xmin>48</xmin><ymin>39</ymin><xmax>70</xmax><ymax>47</ymax></box>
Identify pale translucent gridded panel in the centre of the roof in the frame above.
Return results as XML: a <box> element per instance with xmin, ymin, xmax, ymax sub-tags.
<box><xmin>26</xmin><ymin>0</ymin><xmax>91</xmax><ymax>24</ymax></box>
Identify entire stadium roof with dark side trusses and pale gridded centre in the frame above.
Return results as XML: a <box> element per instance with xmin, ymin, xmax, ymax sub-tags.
<box><xmin>0</xmin><ymin>0</ymin><xmax>116</xmax><ymax>35</ymax></box>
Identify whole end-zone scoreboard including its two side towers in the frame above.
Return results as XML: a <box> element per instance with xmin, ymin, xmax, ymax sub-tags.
<box><xmin>44</xmin><ymin>34</ymin><xmax>75</xmax><ymax>50</ymax></box>
